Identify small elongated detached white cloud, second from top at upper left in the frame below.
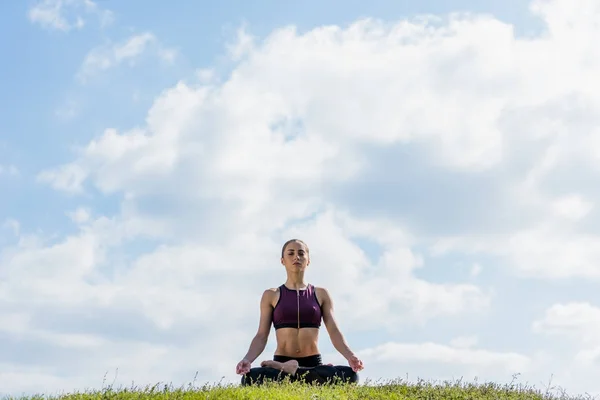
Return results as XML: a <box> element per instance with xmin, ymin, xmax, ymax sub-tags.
<box><xmin>78</xmin><ymin>32</ymin><xmax>177</xmax><ymax>81</ymax></box>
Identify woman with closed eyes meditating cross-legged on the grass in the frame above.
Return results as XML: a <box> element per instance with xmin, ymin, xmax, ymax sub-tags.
<box><xmin>236</xmin><ymin>239</ymin><xmax>363</xmax><ymax>384</ymax></box>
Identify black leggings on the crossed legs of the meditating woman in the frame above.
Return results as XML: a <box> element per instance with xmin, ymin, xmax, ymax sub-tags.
<box><xmin>242</xmin><ymin>354</ymin><xmax>358</xmax><ymax>385</ymax></box>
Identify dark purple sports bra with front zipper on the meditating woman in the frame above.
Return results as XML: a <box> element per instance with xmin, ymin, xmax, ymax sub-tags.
<box><xmin>273</xmin><ymin>284</ymin><xmax>323</xmax><ymax>330</ymax></box>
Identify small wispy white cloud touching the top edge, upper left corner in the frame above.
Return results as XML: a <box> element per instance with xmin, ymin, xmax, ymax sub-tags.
<box><xmin>27</xmin><ymin>0</ymin><xmax>114</xmax><ymax>32</ymax></box>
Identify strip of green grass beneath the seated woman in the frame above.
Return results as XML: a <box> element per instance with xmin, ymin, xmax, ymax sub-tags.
<box><xmin>6</xmin><ymin>379</ymin><xmax>593</xmax><ymax>400</ymax></box>
